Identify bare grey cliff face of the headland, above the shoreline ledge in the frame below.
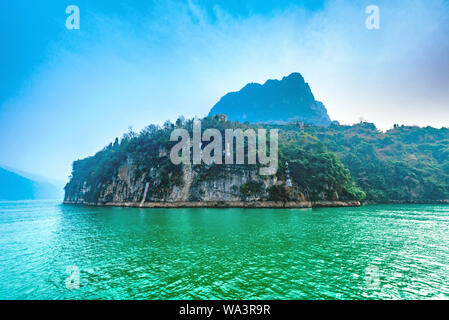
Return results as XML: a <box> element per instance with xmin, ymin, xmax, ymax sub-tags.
<box><xmin>65</xmin><ymin>157</ymin><xmax>278</xmax><ymax>203</ymax></box>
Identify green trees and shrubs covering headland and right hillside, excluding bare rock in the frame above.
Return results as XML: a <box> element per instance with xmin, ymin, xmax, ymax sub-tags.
<box><xmin>65</xmin><ymin>117</ymin><xmax>449</xmax><ymax>202</ymax></box>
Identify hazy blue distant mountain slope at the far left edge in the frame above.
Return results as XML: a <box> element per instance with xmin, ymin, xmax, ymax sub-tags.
<box><xmin>0</xmin><ymin>167</ymin><xmax>61</xmax><ymax>200</ymax></box>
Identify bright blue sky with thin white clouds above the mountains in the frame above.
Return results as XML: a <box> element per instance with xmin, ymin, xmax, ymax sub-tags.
<box><xmin>0</xmin><ymin>0</ymin><xmax>449</xmax><ymax>181</ymax></box>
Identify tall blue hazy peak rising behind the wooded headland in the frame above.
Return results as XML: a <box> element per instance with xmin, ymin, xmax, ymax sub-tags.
<box><xmin>209</xmin><ymin>73</ymin><xmax>331</xmax><ymax>126</ymax></box>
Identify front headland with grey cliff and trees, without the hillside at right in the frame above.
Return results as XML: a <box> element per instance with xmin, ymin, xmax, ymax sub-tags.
<box><xmin>64</xmin><ymin>117</ymin><xmax>364</xmax><ymax>207</ymax></box>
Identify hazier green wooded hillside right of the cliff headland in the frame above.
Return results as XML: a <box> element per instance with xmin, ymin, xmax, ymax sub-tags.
<box><xmin>306</xmin><ymin>122</ymin><xmax>449</xmax><ymax>202</ymax></box>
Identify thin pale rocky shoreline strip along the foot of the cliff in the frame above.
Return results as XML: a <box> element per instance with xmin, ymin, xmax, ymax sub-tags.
<box><xmin>63</xmin><ymin>201</ymin><xmax>361</xmax><ymax>208</ymax></box>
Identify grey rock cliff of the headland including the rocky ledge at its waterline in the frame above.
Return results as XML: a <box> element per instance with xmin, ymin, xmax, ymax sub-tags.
<box><xmin>64</xmin><ymin>157</ymin><xmax>360</xmax><ymax>208</ymax></box>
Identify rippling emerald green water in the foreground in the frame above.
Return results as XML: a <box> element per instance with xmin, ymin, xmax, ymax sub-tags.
<box><xmin>0</xmin><ymin>201</ymin><xmax>449</xmax><ymax>299</ymax></box>
